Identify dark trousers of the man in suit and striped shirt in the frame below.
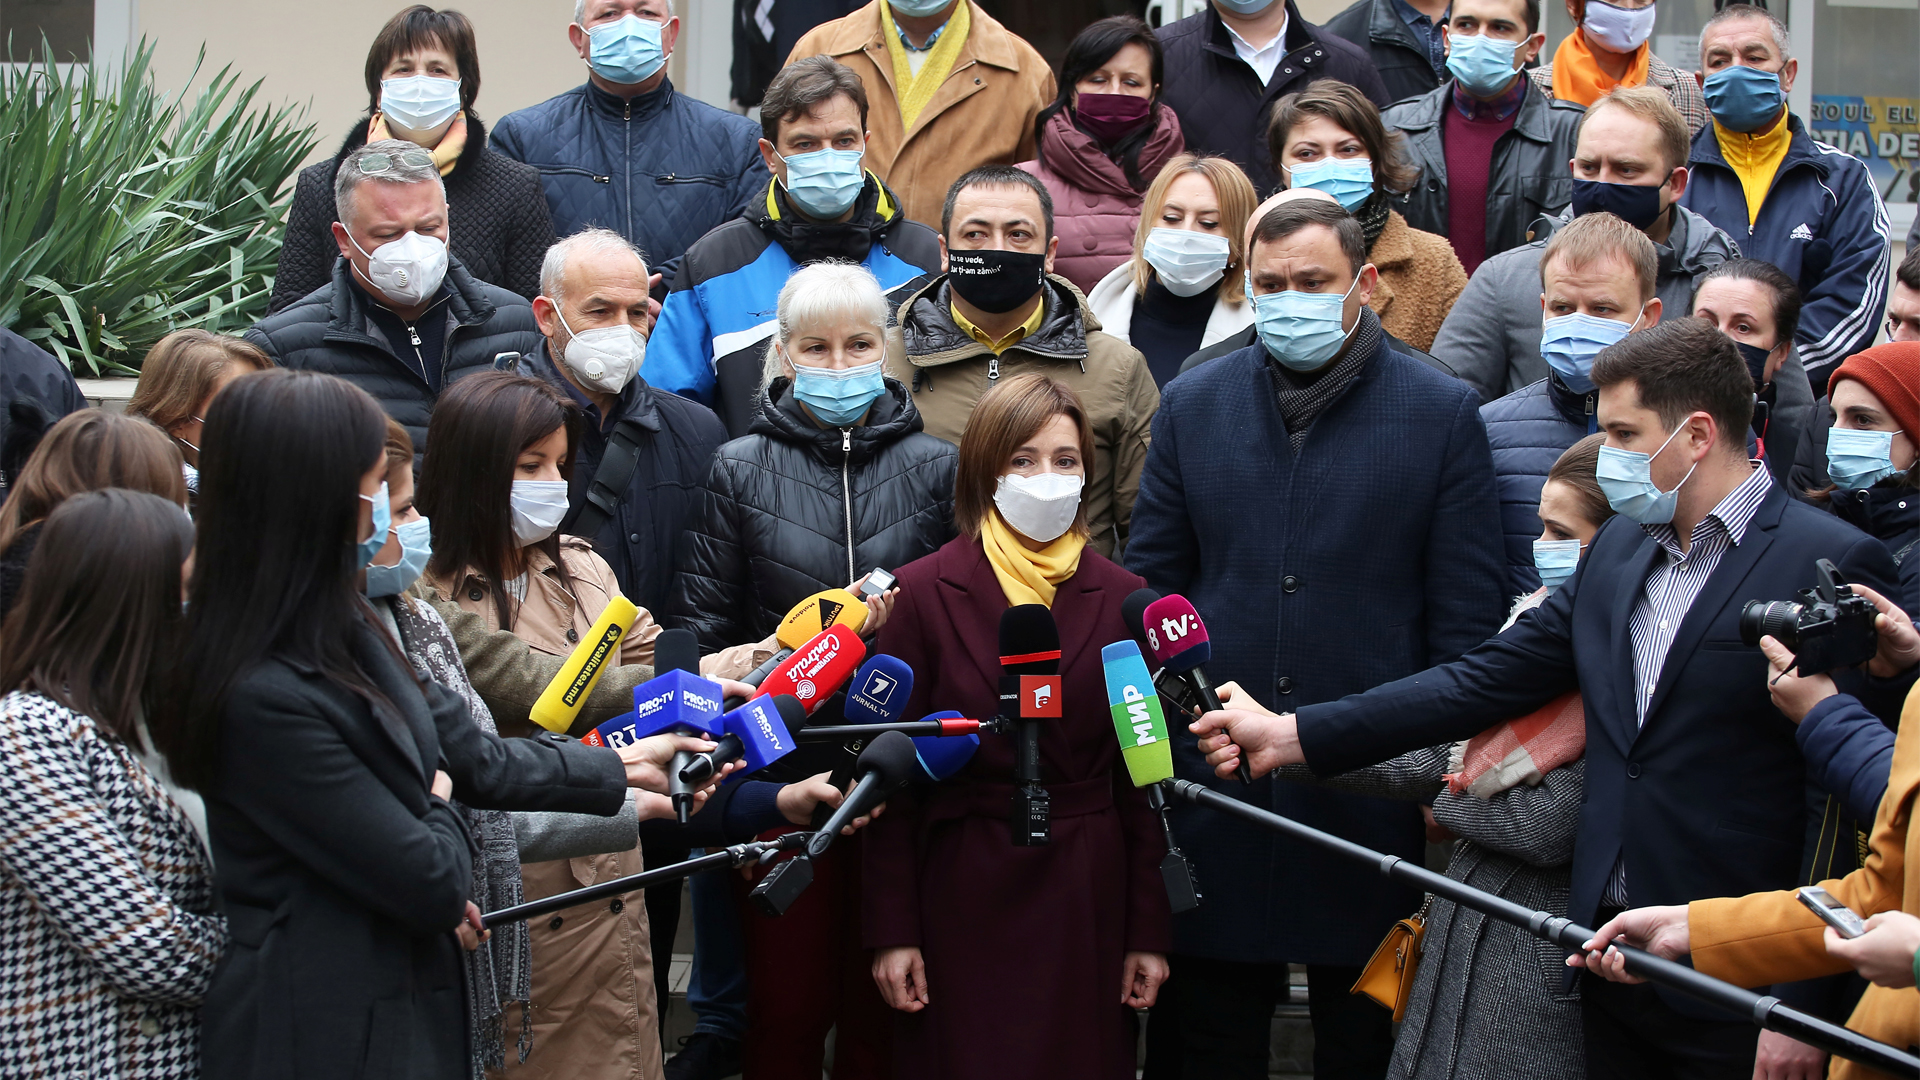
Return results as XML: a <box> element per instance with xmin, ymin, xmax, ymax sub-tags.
<box><xmin>1580</xmin><ymin>968</ymin><xmax>1761</xmax><ymax>1080</ymax></box>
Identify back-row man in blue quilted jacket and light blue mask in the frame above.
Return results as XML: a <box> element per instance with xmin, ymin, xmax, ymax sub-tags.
<box><xmin>493</xmin><ymin>0</ymin><xmax>768</xmax><ymax>296</ymax></box>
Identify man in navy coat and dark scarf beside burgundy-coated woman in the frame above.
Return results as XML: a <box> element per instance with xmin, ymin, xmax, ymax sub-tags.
<box><xmin>1127</xmin><ymin>198</ymin><xmax>1505</xmax><ymax>1078</ymax></box>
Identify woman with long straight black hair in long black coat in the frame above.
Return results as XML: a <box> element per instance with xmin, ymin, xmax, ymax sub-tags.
<box><xmin>152</xmin><ymin>371</ymin><xmax>712</xmax><ymax>1080</ymax></box>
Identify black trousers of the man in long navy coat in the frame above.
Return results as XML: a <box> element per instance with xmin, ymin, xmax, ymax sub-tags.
<box><xmin>1146</xmin><ymin>955</ymin><xmax>1394</xmax><ymax>1080</ymax></box>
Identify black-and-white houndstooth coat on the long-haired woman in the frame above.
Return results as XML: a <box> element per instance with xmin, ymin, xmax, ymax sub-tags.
<box><xmin>0</xmin><ymin>692</ymin><xmax>227</xmax><ymax>1080</ymax></box>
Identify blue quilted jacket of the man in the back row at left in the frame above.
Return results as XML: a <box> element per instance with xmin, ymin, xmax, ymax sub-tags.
<box><xmin>493</xmin><ymin>79</ymin><xmax>768</xmax><ymax>284</ymax></box>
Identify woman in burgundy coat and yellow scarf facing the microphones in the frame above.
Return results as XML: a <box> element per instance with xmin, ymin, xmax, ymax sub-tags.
<box><xmin>864</xmin><ymin>375</ymin><xmax>1171</xmax><ymax>1080</ymax></box>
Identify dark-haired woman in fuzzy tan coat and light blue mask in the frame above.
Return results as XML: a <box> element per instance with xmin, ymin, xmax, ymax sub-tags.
<box><xmin>1267</xmin><ymin>79</ymin><xmax>1467</xmax><ymax>352</ymax></box>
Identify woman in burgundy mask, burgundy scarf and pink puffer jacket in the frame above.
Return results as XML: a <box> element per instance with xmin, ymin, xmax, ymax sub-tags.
<box><xmin>1020</xmin><ymin>15</ymin><xmax>1187</xmax><ymax>292</ymax></box>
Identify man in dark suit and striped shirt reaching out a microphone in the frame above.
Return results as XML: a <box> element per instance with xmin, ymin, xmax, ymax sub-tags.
<box><xmin>1194</xmin><ymin>319</ymin><xmax>1893</xmax><ymax>1080</ymax></box>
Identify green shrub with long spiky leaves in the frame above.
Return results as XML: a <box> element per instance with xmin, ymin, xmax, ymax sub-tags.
<box><xmin>0</xmin><ymin>42</ymin><xmax>315</xmax><ymax>375</ymax></box>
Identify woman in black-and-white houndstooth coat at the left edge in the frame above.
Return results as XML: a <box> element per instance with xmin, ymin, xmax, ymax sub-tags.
<box><xmin>0</xmin><ymin>490</ymin><xmax>227</xmax><ymax>1078</ymax></box>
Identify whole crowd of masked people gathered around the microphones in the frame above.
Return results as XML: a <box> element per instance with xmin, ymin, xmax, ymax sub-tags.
<box><xmin>0</xmin><ymin>0</ymin><xmax>1920</xmax><ymax>1080</ymax></box>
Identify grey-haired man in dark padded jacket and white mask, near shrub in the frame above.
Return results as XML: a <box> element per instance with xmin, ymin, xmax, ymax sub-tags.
<box><xmin>246</xmin><ymin>138</ymin><xmax>541</xmax><ymax>454</ymax></box>
